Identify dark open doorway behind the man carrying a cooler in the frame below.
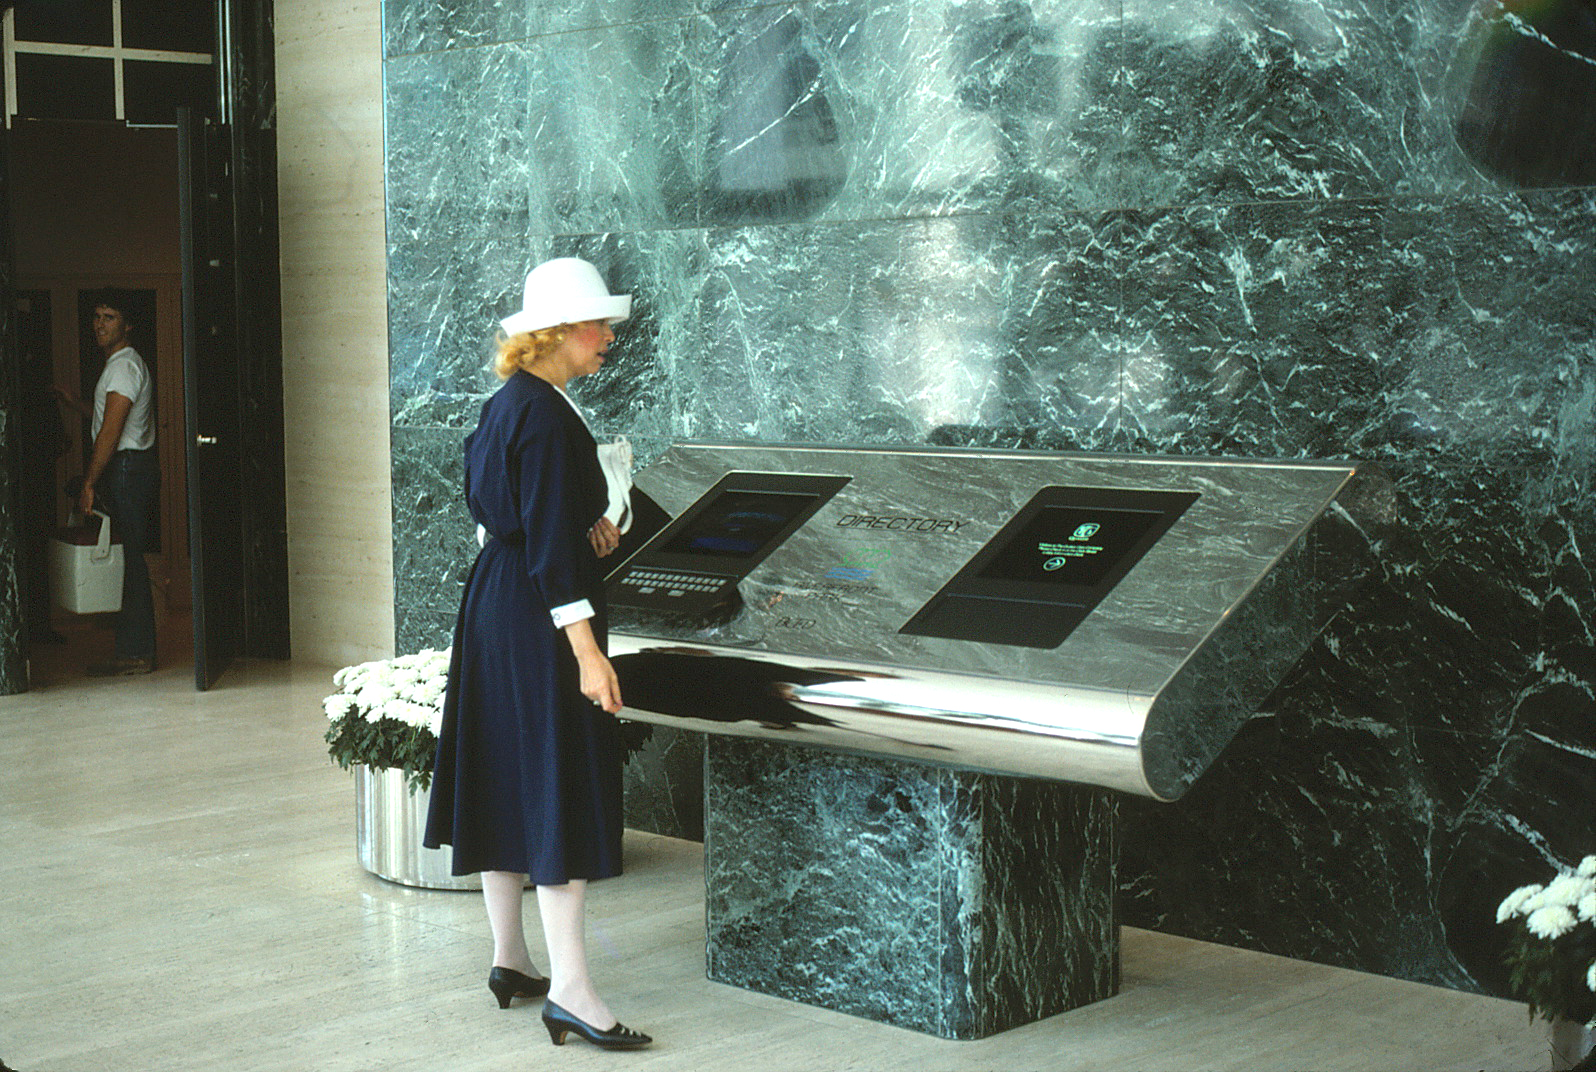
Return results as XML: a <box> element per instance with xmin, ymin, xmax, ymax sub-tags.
<box><xmin>6</xmin><ymin>120</ymin><xmax>192</xmax><ymax>688</ymax></box>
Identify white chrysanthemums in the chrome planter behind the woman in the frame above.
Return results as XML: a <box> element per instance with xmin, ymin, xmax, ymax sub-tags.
<box><xmin>322</xmin><ymin>648</ymin><xmax>653</xmax><ymax>793</ymax></box>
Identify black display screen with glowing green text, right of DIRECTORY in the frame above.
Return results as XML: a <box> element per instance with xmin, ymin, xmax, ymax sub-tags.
<box><xmin>980</xmin><ymin>506</ymin><xmax>1163</xmax><ymax>587</ymax></box>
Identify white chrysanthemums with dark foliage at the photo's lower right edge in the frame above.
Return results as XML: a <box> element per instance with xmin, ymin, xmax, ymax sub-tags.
<box><xmin>1497</xmin><ymin>857</ymin><xmax>1596</xmax><ymax>1024</ymax></box>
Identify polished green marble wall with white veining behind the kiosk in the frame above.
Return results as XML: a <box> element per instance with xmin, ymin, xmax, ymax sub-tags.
<box><xmin>385</xmin><ymin>0</ymin><xmax>1596</xmax><ymax>1008</ymax></box>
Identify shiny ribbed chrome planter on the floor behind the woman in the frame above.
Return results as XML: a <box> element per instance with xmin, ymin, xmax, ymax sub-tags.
<box><xmin>354</xmin><ymin>764</ymin><xmax>482</xmax><ymax>890</ymax></box>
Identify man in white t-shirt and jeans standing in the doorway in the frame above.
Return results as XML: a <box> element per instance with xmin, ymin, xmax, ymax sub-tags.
<box><xmin>78</xmin><ymin>292</ymin><xmax>160</xmax><ymax>676</ymax></box>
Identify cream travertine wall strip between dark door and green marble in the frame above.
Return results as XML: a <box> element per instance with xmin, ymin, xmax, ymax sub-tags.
<box><xmin>276</xmin><ymin>0</ymin><xmax>393</xmax><ymax>665</ymax></box>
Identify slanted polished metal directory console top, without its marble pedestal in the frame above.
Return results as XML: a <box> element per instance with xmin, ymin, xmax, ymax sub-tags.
<box><xmin>608</xmin><ymin>443</ymin><xmax>1368</xmax><ymax>799</ymax></box>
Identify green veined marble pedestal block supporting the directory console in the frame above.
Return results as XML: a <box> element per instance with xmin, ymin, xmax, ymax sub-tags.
<box><xmin>704</xmin><ymin>737</ymin><xmax>1119</xmax><ymax>1039</ymax></box>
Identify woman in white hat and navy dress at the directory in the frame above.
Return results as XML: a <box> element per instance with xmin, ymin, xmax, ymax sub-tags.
<box><xmin>425</xmin><ymin>257</ymin><xmax>650</xmax><ymax>1048</ymax></box>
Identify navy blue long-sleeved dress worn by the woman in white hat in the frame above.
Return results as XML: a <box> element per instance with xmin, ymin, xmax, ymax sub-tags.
<box><xmin>423</xmin><ymin>372</ymin><xmax>622</xmax><ymax>885</ymax></box>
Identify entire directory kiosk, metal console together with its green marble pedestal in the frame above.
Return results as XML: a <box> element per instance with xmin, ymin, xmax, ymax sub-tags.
<box><xmin>606</xmin><ymin>443</ymin><xmax>1389</xmax><ymax>1039</ymax></box>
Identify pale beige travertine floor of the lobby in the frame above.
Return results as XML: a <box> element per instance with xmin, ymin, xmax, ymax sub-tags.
<box><xmin>0</xmin><ymin>664</ymin><xmax>1547</xmax><ymax>1072</ymax></box>
